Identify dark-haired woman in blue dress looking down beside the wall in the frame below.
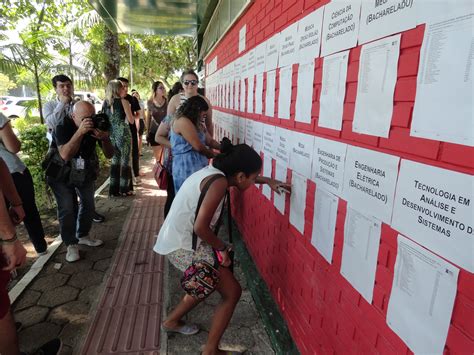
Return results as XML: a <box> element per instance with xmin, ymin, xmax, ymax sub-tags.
<box><xmin>170</xmin><ymin>96</ymin><xmax>220</xmax><ymax>193</ymax></box>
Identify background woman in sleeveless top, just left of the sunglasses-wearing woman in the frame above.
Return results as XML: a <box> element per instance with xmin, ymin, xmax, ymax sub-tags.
<box><xmin>145</xmin><ymin>81</ymin><xmax>168</xmax><ymax>161</ymax></box>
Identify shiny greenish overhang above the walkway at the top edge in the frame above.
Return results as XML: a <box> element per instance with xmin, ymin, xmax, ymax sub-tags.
<box><xmin>89</xmin><ymin>0</ymin><xmax>217</xmax><ymax>37</ymax></box>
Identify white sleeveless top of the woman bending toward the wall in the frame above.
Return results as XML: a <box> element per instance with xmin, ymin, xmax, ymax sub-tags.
<box><xmin>153</xmin><ymin>165</ymin><xmax>224</xmax><ymax>255</ymax></box>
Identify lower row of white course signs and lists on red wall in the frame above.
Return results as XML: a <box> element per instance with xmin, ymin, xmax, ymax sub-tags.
<box><xmin>214</xmin><ymin>110</ymin><xmax>474</xmax><ymax>353</ymax></box>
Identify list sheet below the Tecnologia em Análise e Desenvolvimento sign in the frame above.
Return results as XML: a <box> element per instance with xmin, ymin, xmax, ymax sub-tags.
<box><xmin>387</xmin><ymin>235</ymin><xmax>459</xmax><ymax>354</ymax></box>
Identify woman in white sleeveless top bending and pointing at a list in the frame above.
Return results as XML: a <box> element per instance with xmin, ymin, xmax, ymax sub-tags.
<box><xmin>153</xmin><ymin>141</ymin><xmax>289</xmax><ymax>355</ymax></box>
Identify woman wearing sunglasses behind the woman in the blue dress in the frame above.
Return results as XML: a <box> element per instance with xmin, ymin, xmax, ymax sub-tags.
<box><xmin>168</xmin><ymin>69</ymin><xmax>214</xmax><ymax>137</ymax></box>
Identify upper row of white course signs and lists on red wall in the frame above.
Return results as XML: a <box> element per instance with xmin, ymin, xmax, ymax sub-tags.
<box><xmin>206</xmin><ymin>0</ymin><xmax>474</xmax><ymax>146</ymax></box>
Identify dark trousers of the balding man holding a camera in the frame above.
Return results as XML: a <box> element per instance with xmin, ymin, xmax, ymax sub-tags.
<box><xmin>48</xmin><ymin>179</ymin><xmax>95</xmax><ymax>245</ymax></box>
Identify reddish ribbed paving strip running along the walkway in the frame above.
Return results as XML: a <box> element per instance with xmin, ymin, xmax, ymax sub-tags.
<box><xmin>81</xmin><ymin>176</ymin><xmax>165</xmax><ymax>355</ymax></box>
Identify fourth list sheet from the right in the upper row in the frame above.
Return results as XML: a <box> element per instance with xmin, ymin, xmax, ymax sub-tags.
<box><xmin>295</xmin><ymin>61</ymin><xmax>314</xmax><ymax>123</ymax></box>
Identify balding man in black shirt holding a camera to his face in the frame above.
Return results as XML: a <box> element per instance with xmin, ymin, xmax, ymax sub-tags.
<box><xmin>47</xmin><ymin>101</ymin><xmax>114</xmax><ymax>262</ymax></box>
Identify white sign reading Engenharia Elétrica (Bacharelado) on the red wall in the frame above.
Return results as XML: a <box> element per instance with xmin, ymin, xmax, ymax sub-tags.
<box><xmin>343</xmin><ymin>145</ymin><xmax>400</xmax><ymax>224</ymax></box>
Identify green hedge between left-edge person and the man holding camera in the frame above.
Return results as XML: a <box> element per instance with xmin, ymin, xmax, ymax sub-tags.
<box><xmin>15</xmin><ymin>125</ymin><xmax>51</xmax><ymax>207</ymax></box>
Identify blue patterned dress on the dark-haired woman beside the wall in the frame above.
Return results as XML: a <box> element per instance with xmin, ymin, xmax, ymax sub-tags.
<box><xmin>170</xmin><ymin>128</ymin><xmax>209</xmax><ymax>194</ymax></box>
